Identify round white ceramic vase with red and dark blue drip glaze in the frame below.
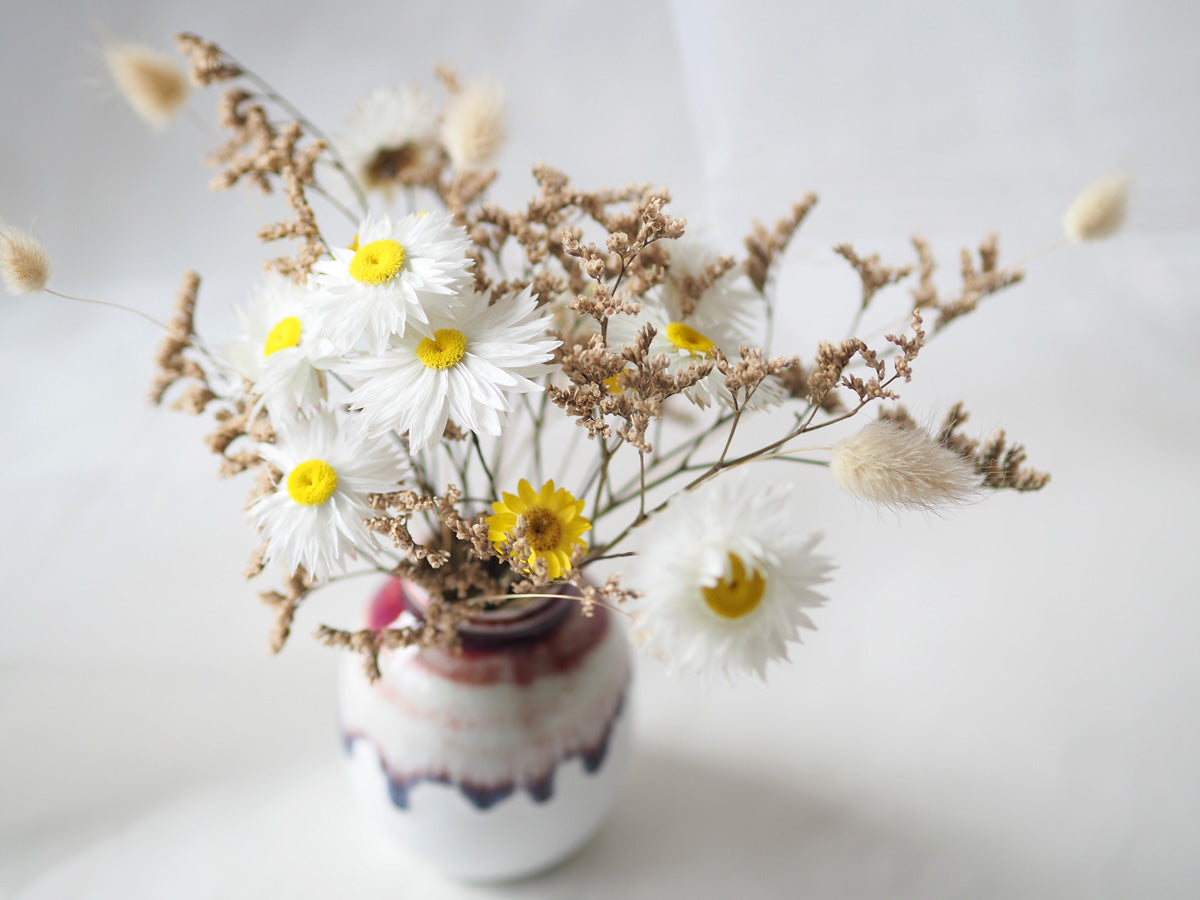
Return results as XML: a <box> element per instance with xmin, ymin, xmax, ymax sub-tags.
<box><xmin>340</xmin><ymin>581</ymin><xmax>630</xmax><ymax>881</ymax></box>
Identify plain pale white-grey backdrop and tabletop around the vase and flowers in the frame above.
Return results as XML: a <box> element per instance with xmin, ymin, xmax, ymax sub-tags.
<box><xmin>0</xmin><ymin>0</ymin><xmax>1200</xmax><ymax>898</ymax></box>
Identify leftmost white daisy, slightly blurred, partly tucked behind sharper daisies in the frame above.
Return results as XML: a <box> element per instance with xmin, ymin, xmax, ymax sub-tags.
<box><xmin>218</xmin><ymin>271</ymin><xmax>338</xmax><ymax>420</ymax></box>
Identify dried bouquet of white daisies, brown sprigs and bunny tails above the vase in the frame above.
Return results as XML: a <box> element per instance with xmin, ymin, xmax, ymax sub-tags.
<box><xmin>0</xmin><ymin>35</ymin><xmax>1127</xmax><ymax>677</ymax></box>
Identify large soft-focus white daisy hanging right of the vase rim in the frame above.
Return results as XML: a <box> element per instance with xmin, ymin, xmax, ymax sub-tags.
<box><xmin>628</xmin><ymin>472</ymin><xmax>832</xmax><ymax>677</ymax></box>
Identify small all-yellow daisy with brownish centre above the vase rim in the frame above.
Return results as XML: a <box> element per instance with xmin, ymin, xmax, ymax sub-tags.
<box><xmin>487</xmin><ymin>479</ymin><xmax>592</xmax><ymax>578</ymax></box>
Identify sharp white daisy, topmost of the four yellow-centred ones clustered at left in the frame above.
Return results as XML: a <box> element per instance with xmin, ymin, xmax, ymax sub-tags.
<box><xmin>314</xmin><ymin>212</ymin><xmax>470</xmax><ymax>353</ymax></box>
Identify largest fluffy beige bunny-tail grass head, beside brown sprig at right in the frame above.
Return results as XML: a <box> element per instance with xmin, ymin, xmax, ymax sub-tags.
<box><xmin>830</xmin><ymin>421</ymin><xmax>979</xmax><ymax>509</ymax></box>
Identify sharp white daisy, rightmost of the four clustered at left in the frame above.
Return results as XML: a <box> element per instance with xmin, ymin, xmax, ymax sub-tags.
<box><xmin>343</xmin><ymin>288</ymin><xmax>559</xmax><ymax>452</ymax></box>
